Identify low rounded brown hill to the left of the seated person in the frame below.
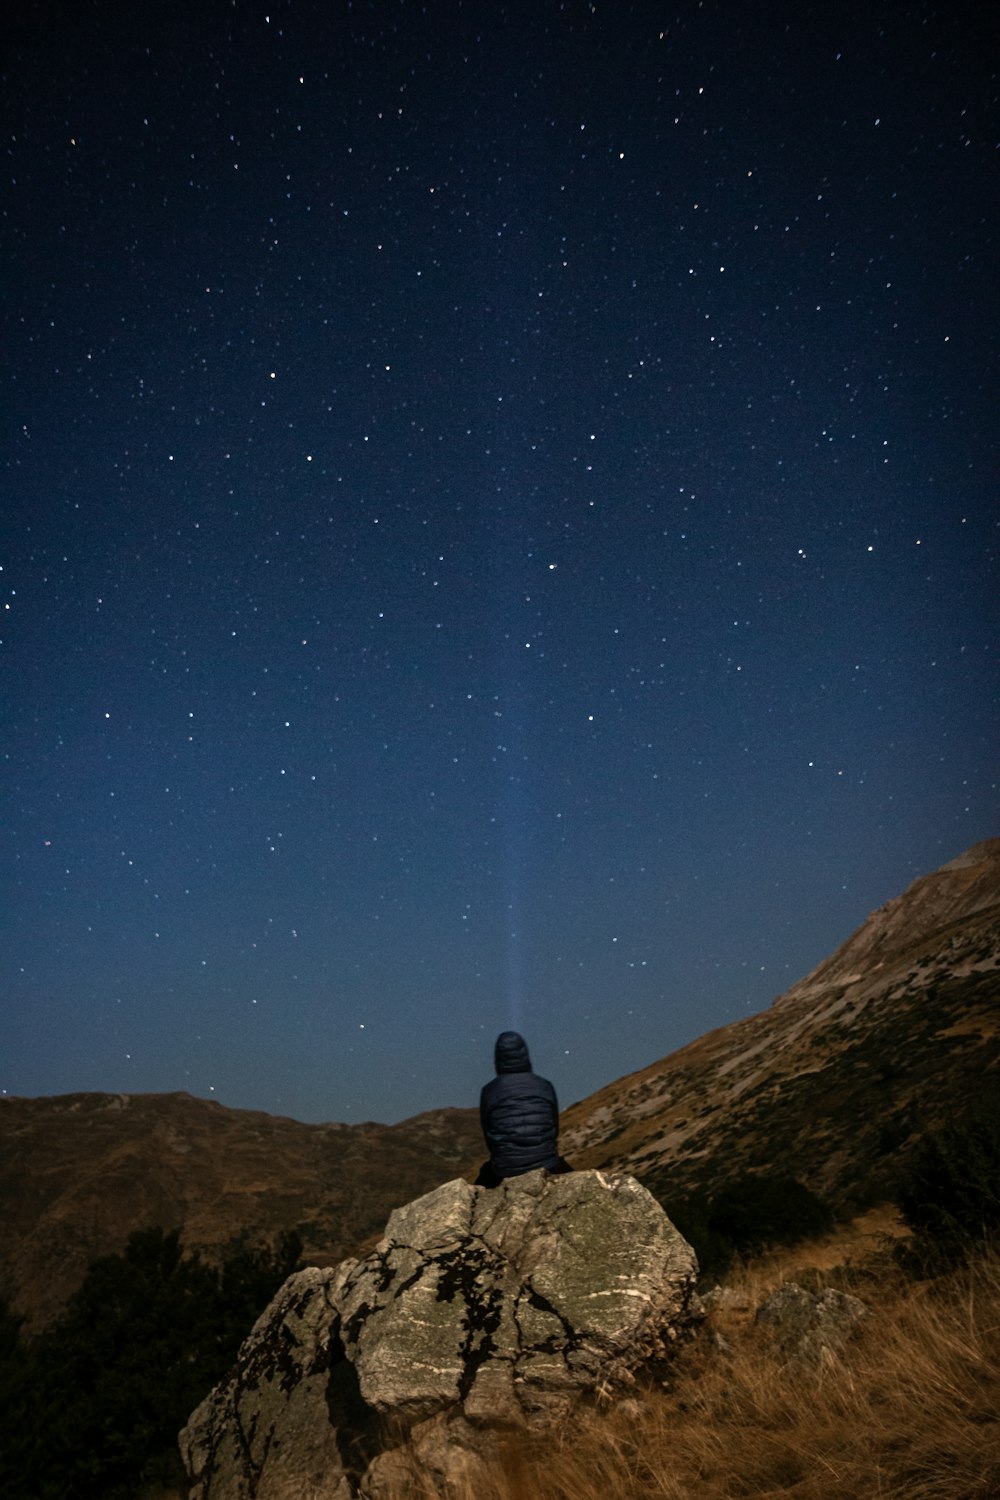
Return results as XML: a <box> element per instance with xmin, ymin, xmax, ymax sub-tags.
<box><xmin>0</xmin><ymin>1094</ymin><xmax>483</xmax><ymax>1328</ymax></box>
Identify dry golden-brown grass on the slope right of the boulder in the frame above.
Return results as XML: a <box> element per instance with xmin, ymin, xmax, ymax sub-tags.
<box><xmin>467</xmin><ymin>1256</ymin><xmax>1000</xmax><ymax>1500</ymax></box>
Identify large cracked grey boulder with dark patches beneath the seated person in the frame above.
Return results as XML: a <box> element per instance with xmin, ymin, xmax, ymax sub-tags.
<box><xmin>180</xmin><ymin>1172</ymin><xmax>702</xmax><ymax>1500</ymax></box>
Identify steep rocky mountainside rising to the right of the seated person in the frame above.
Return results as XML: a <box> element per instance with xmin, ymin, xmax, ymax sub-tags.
<box><xmin>562</xmin><ymin>839</ymin><xmax>1000</xmax><ymax>1209</ymax></box>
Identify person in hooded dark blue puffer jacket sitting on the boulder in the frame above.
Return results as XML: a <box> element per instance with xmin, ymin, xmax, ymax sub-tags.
<box><xmin>475</xmin><ymin>1032</ymin><xmax>573</xmax><ymax>1188</ymax></box>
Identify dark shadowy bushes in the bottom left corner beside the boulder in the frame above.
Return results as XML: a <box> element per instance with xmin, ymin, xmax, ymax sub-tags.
<box><xmin>0</xmin><ymin>1229</ymin><xmax>301</xmax><ymax>1500</ymax></box>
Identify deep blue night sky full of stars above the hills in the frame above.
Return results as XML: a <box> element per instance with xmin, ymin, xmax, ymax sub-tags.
<box><xmin>0</xmin><ymin>0</ymin><xmax>1000</xmax><ymax>1122</ymax></box>
